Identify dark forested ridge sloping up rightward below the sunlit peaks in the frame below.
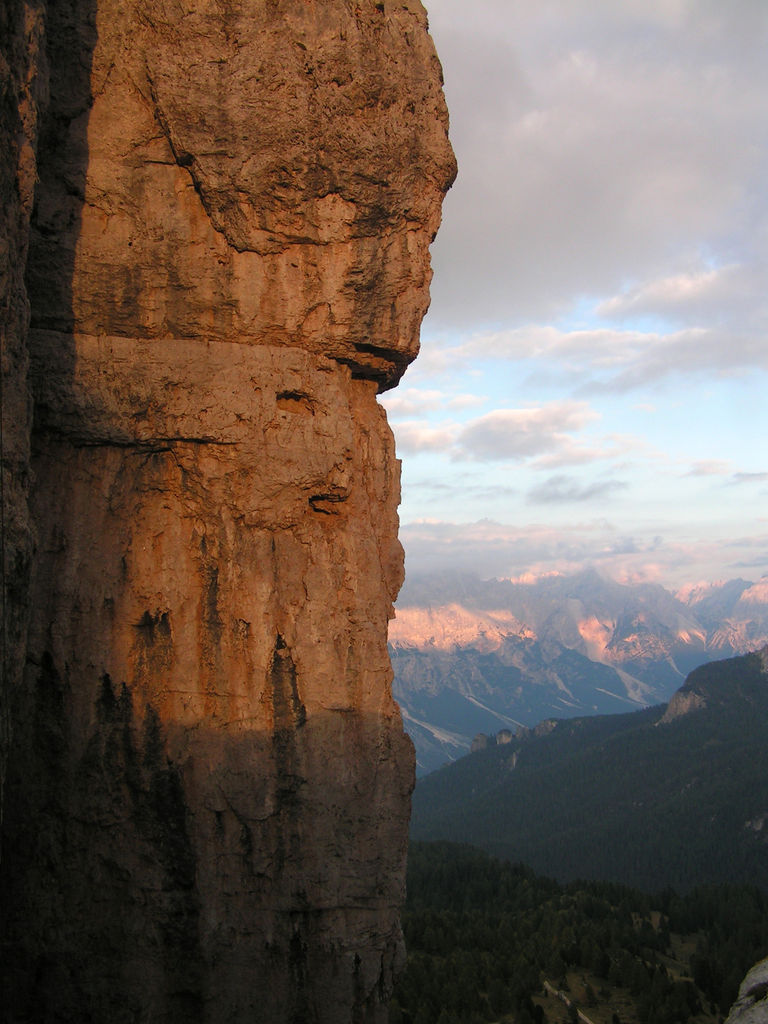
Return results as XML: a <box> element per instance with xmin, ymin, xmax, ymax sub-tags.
<box><xmin>412</xmin><ymin>647</ymin><xmax>768</xmax><ymax>892</ymax></box>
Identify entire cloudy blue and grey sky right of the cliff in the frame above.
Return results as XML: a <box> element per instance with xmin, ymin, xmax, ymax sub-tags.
<box><xmin>382</xmin><ymin>0</ymin><xmax>768</xmax><ymax>589</ymax></box>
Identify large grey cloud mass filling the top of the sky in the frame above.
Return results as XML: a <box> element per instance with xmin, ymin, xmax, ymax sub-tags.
<box><xmin>423</xmin><ymin>0</ymin><xmax>768</xmax><ymax>335</ymax></box>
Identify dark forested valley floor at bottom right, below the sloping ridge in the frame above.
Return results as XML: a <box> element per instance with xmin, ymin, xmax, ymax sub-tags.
<box><xmin>389</xmin><ymin>843</ymin><xmax>768</xmax><ymax>1024</ymax></box>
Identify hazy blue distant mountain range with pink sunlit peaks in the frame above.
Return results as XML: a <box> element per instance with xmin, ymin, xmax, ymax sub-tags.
<box><xmin>389</xmin><ymin>569</ymin><xmax>768</xmax><ymax>774</ymax></box>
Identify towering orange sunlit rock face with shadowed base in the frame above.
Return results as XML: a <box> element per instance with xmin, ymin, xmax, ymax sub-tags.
<box><xmin>0</xmin><ymin>0</ymin><xmax>454</xmax><ymax>1024</ymax></box>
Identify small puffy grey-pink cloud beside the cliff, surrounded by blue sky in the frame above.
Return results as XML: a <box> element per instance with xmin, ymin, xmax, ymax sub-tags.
<box><xmin>457</xmin><ymin>401</ymin><xmax>597</xmax><ymax>461</ymax></box>
